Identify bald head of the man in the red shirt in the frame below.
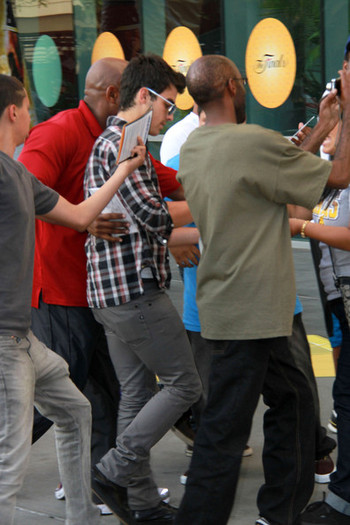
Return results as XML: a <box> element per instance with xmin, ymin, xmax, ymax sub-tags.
<box><xmin>84</xmin><ymin>57</ymin><xmax>128</xmax><ymax>129</ymax></box>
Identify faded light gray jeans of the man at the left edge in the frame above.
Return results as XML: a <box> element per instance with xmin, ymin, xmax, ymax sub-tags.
<box><xmin>0</xmin><ymin>332</ymin><xmax>99</xmax><ymax>525</ymax></box>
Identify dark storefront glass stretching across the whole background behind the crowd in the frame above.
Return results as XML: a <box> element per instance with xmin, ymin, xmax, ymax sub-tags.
<box><xmin>0</xmin><ymin>0</ymin><xmax>350</xmax><ymax>134</ymax></box>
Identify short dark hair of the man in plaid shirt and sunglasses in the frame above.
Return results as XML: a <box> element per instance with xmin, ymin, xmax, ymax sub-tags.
<box><xmin>119</xmin><ymin>53</ymin><xmax>186</xmax><ymax>111</ymax></box>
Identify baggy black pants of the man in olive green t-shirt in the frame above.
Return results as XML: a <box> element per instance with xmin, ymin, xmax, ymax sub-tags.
<box><xmin>176</xmin><ymin>337</ymin><xmax>315</xmax><ymax>525</ymax></box>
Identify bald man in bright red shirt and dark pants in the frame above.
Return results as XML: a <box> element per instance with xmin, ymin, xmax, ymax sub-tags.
<box><xmin>19</xmin><ymin>58</ymin><xmax>183</xmax><ymax>513</ymax></box>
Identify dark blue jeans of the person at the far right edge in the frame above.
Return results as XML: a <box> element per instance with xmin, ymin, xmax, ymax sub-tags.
<box><xmin>329</xmin><ymin>299</ymin><xmax>350</xmax><ymax>515</ymax></box>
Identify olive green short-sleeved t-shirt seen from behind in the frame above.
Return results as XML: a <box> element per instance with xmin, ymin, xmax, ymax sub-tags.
<box><xmin>178</xmin><ymin>124</ymin><xmax>332</xmax><ymax>339</ymax></box>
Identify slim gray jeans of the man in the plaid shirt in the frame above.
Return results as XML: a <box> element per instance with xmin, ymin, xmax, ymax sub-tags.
<box><xmin>93</xmin><ymin>285</ymin><xmax>201</xmax><ymax>510</ymax></box>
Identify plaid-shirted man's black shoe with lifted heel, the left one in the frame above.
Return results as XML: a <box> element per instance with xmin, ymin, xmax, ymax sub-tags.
<box><xmin>91</xmin><ymin>467</ymin><xmax>136</xmax><ymax>525</ymax></box>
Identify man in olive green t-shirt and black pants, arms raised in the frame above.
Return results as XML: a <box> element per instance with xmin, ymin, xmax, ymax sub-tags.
<box><xmin>176</xmin><ymin>55</ymin><xmax>350</xmax><ymax>525</ymax></box>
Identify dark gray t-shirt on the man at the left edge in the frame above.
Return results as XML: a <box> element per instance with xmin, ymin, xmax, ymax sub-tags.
<box><xmin>0</xmin><ymin>151</ymin><xmax>59</xmax><ymax>337</ymax></box>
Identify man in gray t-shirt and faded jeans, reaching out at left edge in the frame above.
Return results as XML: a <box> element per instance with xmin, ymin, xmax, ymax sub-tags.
<box><xmin>0</xmin><ymin>75</ymin><xmax>145</xmax><ymax>525</ymax></box>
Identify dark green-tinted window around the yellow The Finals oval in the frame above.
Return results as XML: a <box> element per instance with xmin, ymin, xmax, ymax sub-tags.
<box><xmin>224</xmin><ymin>0</ymin><xmax>349</xmax><ymax>135</ymax></box>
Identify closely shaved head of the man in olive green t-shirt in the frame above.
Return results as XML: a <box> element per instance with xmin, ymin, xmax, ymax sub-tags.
<box><xmin>186</xmin><ymin>55</ymin><xmax>241</xmax><ymax>106</ymax></box>
